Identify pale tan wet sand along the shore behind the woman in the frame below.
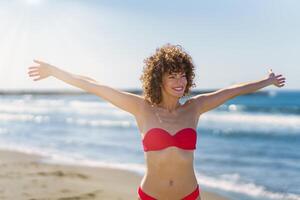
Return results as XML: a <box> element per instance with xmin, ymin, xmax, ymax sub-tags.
<box><xmin>0</xmin><ymin>150</ymin><xmax>226</xmax><ymax>200</ymax></box>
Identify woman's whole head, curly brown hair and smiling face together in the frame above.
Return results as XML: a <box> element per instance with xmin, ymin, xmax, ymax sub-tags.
<box><xmin>140</xmin><ymin>43</ymin><xmax>196</xmax><ymax>105</ymax></box>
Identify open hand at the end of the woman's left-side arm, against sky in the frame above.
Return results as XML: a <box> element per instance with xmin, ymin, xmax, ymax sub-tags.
<box><xmin>28</xmin><ymin>60</ymin><xmax>52</xmax><ymax>81</ymax></box>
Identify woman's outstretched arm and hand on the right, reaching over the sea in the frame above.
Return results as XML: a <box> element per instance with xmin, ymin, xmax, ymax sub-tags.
<box><xmin>191</xmin><ymin>70</ymin><xmax>285</xmax><ymax>116</ymax></box>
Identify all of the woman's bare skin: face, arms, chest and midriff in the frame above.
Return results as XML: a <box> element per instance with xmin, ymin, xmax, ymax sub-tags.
<box><xmin>28</xmin><ymin>60</ymin><xmax>285</xmax><ymax>200</ymax></box>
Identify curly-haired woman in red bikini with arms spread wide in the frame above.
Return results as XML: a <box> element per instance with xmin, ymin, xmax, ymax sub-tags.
<box><xmin>28</xmin><ymin>44</ymin><xmax>285</xmax><ymax>200</ymax></box>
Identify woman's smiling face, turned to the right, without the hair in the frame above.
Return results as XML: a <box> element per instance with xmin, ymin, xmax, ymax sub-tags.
<box><xmin>162</xmin><ymin>72</ymin><xmax>187</xmax><ymax>98</ymax></box>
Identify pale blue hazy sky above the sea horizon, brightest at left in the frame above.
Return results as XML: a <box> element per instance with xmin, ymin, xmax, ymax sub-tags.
<box><xmin>0</xmin><ymin>0</ymin><xmax>300</xmax><ymax>90</ymax></box>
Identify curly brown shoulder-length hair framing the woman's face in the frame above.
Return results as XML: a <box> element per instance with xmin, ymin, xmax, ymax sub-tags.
<box><xmin>140</xmin><ymin>43</ymin><xmax>196</xmax><ymax>105</ymax></box>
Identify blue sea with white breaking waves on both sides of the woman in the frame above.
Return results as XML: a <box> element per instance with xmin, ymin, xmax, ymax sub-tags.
<box><xmin>0</xmin><ymin>90</ymin><xmax>300</xmax><ymax>200</ymax></box>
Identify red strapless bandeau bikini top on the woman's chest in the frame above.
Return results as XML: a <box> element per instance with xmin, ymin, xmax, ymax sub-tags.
<box><xmin>142</xmin><ymin>128</ymin><xmax>197</xmax><ymax>151</ymax></box>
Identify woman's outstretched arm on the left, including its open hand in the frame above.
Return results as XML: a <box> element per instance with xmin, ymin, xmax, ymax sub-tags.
<box><xmin>28</xmin><ymin>60</ymin><xmax>144</xmax><ymax>116</ymax></box>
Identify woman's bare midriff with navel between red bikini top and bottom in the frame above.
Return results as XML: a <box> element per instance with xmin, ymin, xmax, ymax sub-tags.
<box><xmin>141</xmin><ymin>147</ymin><xmax>197</xmax><ymax>199</ymax></box>
